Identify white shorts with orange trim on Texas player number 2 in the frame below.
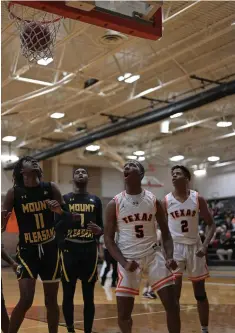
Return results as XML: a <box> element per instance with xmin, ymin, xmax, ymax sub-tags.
<box><xmin>174</xmin><ymin>242</ymin><xmax>209</xmax><ymax>281</ymax></box>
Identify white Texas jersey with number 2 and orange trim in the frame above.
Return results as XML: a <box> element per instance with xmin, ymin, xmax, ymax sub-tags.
<box><xmin>165</xmin><ymin>190</ymin><xmax>199</xmax><ymax>245</ymax></box>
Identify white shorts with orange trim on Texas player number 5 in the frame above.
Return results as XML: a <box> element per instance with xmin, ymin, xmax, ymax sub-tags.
<box><xmin>116</xmin><ymin>250</ymin><xmax>175</xmax><ymax>296</ymax></box>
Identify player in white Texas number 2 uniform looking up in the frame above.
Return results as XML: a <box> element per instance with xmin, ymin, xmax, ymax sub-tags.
<box><xmin>165</xmin><ymin>165</ymin><xmax>216</xmax><ymax>333</ymax></box>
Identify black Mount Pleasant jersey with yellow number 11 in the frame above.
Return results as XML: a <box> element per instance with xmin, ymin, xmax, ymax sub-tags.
<box><xmin>14</xmin><ymin>182</ymin><xmax>55</xmax><ymax>245</ymax></box>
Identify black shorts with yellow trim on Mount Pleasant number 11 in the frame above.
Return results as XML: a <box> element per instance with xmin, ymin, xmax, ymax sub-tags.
<box><xmin>16</xmin><ymin>239</ymin><xmax>60</xmax><ymax>282</ymax></box>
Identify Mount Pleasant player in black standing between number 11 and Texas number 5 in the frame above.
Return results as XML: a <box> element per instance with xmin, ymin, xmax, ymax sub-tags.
<box><xmin>61</xmin><ymin>168</ymin><xmax>103</xmax><ymax>333</ymax></box>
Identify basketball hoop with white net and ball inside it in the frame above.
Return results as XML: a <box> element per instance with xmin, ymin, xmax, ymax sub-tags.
<box><xmin>7</xmin><ymin>1</ymin><xmax>63</xmax><ymax>62</ymax></box>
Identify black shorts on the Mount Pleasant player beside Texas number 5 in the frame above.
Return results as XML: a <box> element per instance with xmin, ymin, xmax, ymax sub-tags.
<box><xmin>61</xmin><ymin>241</ymin><xmax>98</xmax><ymax>282</ymax></box>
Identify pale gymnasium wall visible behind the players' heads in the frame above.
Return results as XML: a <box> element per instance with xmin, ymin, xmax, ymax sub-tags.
<box><xmin>1</xmin><ymin>161</ymin><xmax>235</xmax><ymax>199</ymax></box>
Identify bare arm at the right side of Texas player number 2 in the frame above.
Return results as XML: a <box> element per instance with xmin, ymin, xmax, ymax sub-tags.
<box><xmin>197</xmin><ymin>195</ymin><xmax>216</xmax><ymax>257</ymax></box>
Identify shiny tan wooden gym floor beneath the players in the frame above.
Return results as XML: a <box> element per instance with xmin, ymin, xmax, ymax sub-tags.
<box><xmin>2</xmin><ymin>268</ymin><xmax>235</xmax><ymax>333</ymax></box>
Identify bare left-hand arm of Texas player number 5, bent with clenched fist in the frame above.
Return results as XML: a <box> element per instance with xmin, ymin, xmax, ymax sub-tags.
<box><xmin>104</xmin><ymin>200</ymin><xmax>127</xmax><ymax>268</ymax></box>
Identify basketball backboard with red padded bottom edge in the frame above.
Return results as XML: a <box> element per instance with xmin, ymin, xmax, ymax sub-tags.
<box><xmin>8</xmin><ymin>1</ymin><xmax>162</xmax><ymax>40</ymax></box>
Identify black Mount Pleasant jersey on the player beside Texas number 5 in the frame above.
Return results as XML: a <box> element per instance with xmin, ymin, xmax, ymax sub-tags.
<box><xmin>64</xmin><ymin>192</ymin><xmax>103</xmax><ymax>241</ymax></box>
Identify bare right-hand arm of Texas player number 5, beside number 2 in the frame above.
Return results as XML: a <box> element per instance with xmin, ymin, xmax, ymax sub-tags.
<box><xmin>156</xmin><ymin>200</ymin><xmax>177</xmax><ymax>270</ymax></box>
